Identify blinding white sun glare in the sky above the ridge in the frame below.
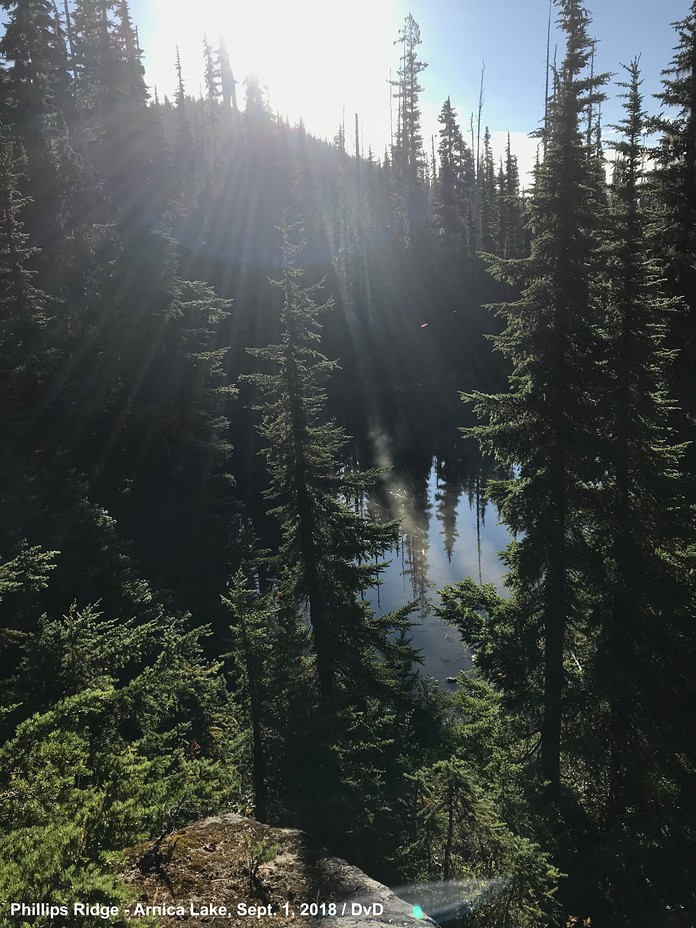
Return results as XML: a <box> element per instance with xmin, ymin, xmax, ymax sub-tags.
<box><xmin>155</xmin><ymin>0</ymin><xmax>400</xmax><ymax>148</ymax></box>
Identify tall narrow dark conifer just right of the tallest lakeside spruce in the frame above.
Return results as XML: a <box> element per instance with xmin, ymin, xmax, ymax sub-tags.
<box><xmin>601</xmin><ymin>59</ymin><xmax>683</xmax><ymax>809</ymax></box>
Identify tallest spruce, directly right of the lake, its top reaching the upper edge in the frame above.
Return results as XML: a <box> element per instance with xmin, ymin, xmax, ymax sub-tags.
<box><xmin>462</xmin><ymin>0</ymin><xmax>606</xmax><ymax>795</ymax></box>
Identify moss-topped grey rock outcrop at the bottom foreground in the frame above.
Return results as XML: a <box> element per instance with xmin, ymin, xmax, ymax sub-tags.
<box><xmin>126</xmin><ymin>814</ymin><xmax>435</xmax><ymax>928</ymax></box>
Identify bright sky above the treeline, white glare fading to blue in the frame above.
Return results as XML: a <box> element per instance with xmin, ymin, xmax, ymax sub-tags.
<box><xmin>132</xmin><ymin>0</ymin><xmax>689</xmax><ymax>178</ymax></box>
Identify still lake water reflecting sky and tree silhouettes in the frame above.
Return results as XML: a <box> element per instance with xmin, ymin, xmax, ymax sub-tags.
<box><xmin>235</xmin><ymin>395</ymin><xmax>510</xmax><ymax>687</ymax></box>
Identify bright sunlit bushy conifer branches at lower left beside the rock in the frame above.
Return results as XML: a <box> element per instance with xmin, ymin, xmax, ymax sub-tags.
<box><xmin>0</xmin><ymin>549</ymin><xmax>239</xmax><ymax>903</ymax></box>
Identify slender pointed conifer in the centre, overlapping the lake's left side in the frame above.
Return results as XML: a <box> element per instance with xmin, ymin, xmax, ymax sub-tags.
<box><xmin>248</xmin><ymin>227</ymin><xmax>405</xmax><ymax>703</ymax></box>
